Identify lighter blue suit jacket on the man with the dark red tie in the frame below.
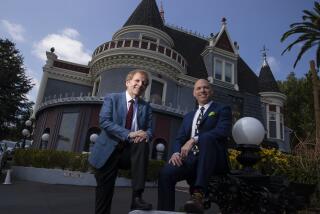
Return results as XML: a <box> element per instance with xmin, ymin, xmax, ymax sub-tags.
<box><xmin>89</xmin><ymin>92</ymin><xmax>152</xmax><ymax>169</ymax></box>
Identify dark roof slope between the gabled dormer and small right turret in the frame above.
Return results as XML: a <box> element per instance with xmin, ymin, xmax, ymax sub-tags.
<box><xmin>237</xmin><ymin>57</ymin><xmax>259</xmax><ymax>95</ymax></box>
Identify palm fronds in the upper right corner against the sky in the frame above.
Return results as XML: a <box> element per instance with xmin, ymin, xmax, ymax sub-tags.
<box><xmin>281</xmin><ymin>2</ymin><xmax>320</xmax><ymax>68</ymax></box>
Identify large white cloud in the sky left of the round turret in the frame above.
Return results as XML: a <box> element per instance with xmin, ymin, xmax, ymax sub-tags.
<box><xmin>32</xmin><ymin>28</ymin><xmax>91</xmax><ymax>64</ymax></box>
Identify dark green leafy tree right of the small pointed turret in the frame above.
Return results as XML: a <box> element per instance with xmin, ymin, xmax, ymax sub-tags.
<box><xmin>278</xmin><ymin>72</ymin><xmax>315</xmax><ymax>143</ymax></box>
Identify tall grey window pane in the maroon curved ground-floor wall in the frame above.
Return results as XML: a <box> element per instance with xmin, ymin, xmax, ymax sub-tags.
<box><xmin>57</xmin><ymin>113</ymin><xmax>79</xmax><ymax>151</ymax></box>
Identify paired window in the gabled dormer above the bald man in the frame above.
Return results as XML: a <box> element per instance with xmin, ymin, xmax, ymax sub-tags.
<box><xmin>214</xmin><ymin>58</ymin><xmax>234</xmax><ymax>84</ymax></box>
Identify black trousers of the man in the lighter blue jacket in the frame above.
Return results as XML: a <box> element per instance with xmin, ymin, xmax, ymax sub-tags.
<box><xmin>95</xmin><ymin>143</ymin><xmax>149</xmax><ymax>214</ymax></box>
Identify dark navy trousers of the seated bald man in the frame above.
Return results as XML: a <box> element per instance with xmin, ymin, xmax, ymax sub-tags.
<box><xmin>158</xmin><ymin>142</ymin><xmax>228</xmax><ymax>211</ymax></box>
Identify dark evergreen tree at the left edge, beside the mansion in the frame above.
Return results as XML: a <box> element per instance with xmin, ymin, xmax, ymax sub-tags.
<box><xmin>0</xmin><ymin>38</ymin><xmax>33</xmax><ymax>139</ymax></box>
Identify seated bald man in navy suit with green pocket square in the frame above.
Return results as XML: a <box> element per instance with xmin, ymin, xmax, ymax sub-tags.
<box><xmin>158</xmin><ymin>79</ymin><xmax>232</xmax><ymax>213</ymax></box>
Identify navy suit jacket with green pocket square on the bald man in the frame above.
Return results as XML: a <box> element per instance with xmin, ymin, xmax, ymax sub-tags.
<box><xmin>173</xmin><ymin>102</ymin><xmax>232</xmax><ymax>153</ymax></box>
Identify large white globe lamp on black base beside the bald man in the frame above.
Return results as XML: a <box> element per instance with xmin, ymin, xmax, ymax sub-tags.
<box><xmin>232</xmin><ymin>117</ymin><xmax>265</xmax><ymax>174</ymax></box>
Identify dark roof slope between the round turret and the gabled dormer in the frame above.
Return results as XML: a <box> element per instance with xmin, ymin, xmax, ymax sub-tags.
<box><xmin>164</xmin><ymin>26</ymin><xmax>208</xmax><ymax>78</ymax></box>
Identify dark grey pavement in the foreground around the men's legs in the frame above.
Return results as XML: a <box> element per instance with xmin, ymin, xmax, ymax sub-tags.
<box><xmin>0</xmin><ymin>179</ymin><xmax>216</xmax><ymax>214</ymax></box>
